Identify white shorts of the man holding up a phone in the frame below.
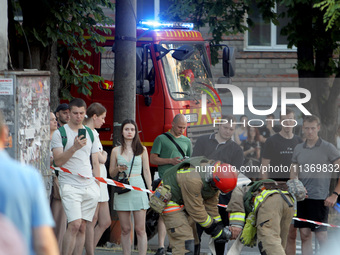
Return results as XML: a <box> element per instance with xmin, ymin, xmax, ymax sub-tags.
<box><xmin>60</xmin><ymin>182</ymin><xmax>100</xmax><ymax>223</ymax></box>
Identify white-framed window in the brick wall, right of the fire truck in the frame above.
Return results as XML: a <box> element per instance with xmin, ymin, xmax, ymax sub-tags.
<box><xmin>245</xmin><ymin>2</ymin><xmax>296</xmax><ymax>51</ymax></box>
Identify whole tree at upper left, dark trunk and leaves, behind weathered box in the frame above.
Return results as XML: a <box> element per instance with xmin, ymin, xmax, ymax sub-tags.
<box><xmin>8</xmin><ymin>0</ymin><xmax>113</xmax><ymax>108</ymax></box>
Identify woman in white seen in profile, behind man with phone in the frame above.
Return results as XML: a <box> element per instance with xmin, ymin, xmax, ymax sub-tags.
<box><xmin>85</xmin><ymin>103</ymin><xmax>111</xmax><ymax>254</ymax></box>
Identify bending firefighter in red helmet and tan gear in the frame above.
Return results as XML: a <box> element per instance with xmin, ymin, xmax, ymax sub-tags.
<box><xmin>150</xmin><ymin>157</ymin><xmax>237</xmax><ymax>255</ymax></box>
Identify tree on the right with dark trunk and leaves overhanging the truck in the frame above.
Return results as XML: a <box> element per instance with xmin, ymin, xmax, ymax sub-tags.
<box><xmin>164</xmin><ymin>0</ymin><xmax>340</xmax><ymax>143</ymax></box>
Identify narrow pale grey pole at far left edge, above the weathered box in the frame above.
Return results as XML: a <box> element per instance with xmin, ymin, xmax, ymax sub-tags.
<box><xmin>0</xmin><ymin>0</ymin><xmax>8</xmax><ymax>70</ymax></box>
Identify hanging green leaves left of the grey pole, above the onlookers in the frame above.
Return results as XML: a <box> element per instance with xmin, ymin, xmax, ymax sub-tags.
<box><xmin>11</xmin><ymin>0</ymin><xmax>114</xmax><ymax>99</ymax></box>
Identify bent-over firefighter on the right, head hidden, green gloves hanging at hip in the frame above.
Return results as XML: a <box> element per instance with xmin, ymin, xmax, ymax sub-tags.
<box><xmin>227</xmin><ymin>179</ymin><xmax>306</xmax><ymax>255</ymax></box>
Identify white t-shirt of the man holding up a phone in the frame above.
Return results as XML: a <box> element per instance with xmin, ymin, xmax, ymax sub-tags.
<box><xmin>51</xmin><ymin>124</ymin><xmax>100</xmax><ymax>186</ymax></box>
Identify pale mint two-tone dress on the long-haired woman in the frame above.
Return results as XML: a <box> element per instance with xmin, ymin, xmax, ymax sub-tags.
<box><xmin>113</xmin><ymin>154</ymin><xmax>149</xmax><ymax>211</ymax></box>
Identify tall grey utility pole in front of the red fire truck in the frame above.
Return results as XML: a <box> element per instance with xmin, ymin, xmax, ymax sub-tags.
<box><xmin>113</xmin><ymin>0</ymin><xmax>137</xmax><ymax>146</ymax></box>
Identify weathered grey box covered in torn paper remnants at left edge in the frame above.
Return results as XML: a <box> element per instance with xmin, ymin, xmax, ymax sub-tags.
<box><xmin>0</xmin><ymin>71</ymin><xmax>52</xmax><ymax>198</ymax></box>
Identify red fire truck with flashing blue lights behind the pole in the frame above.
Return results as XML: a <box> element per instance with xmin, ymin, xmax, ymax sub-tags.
<box><xmin>71</xmin><ymin>22</ymin><xmax>229</xmax><ymax>161</ymax></box>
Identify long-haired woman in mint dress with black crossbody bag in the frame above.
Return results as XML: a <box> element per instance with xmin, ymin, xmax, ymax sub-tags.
<box><xmin>109</xmin><ymin>119</ymin><xmax>151</xmax><ymax>255</ymax></box>
